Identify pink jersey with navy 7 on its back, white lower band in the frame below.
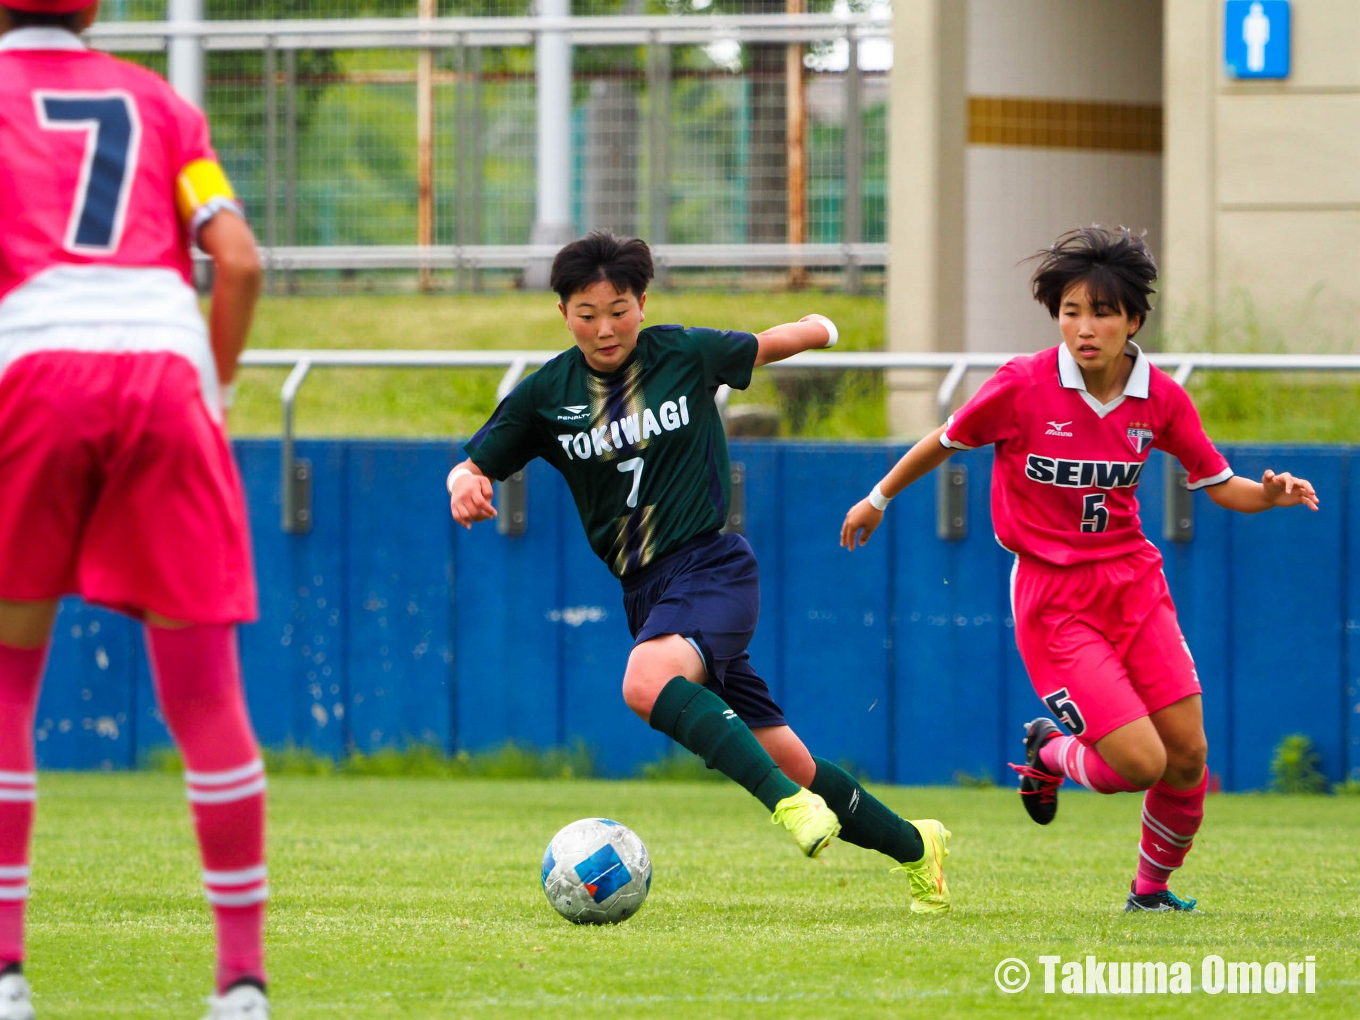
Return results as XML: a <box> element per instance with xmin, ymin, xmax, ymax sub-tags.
<box><xmin>0</xmin><ymin>29</ymin><xmax>239</xmax><ymax>340</ymax></box>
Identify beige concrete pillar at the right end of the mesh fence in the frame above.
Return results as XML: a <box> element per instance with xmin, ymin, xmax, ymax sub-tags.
<box><xmin>888</xmin><ymin>0</ymin><xmax>968</xmax><ymax>437</ymax></box>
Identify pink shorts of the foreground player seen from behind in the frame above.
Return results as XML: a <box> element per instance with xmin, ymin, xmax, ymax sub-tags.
<box><xmin>0</xmin><ymin>351</ymin><xmax>256</xmax><ymax>623</ymax></box>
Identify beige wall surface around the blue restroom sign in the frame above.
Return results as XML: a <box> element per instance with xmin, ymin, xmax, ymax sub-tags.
<box><xmin>1163</xmin><ymin>0</ymin><xmax>1360</xmax><ymax>352</ymax></box>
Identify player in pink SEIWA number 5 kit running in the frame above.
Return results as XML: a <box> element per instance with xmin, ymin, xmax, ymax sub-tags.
<box><xmin>840</xmin><ymin>227</ymin><xmax>1318</xmax><ymax>911</ymax></box>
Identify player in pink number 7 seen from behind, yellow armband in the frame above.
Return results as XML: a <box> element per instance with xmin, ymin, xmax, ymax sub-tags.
<box><xmin>0</xmin><ymin>0</ymin><xmax>268</xmax><ymax>1020</ymax></box>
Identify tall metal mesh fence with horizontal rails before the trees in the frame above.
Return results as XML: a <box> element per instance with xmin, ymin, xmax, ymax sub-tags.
<box><xmin>91</xmin><ymin>0</ymin><xmax>889</xmax><ymax>287</ymax></box>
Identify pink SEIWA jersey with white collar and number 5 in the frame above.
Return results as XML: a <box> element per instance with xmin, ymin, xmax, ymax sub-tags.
<box><xmin>940</xmin><ymin>343</ymin><xmax>1232</xmax><ymax>566</ymax></box>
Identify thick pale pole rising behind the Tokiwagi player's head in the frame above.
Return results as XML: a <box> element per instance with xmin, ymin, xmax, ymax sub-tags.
<box><xmin>525</xmin><ymin>0</ymin><xmax>575</xmax><ymax>290</ymax></box>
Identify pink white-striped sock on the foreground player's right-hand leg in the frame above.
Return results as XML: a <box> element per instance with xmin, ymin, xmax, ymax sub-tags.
<box><xmin>147</xmin><ymin>624</ymin><xmax>269</xmax><ymax>993</ymax></box>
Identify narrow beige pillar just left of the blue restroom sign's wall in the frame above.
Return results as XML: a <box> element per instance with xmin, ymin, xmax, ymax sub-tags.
<box><xmin>1157</xmin><ymin>0</ymin><xmax>1223</xmax><ymax>350</ymax></box>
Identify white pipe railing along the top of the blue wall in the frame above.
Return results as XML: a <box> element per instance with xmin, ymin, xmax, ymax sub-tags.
<box><xmin>241</xmin><ymin>350</ymin><xmax>1360</xmax><ymax>541</ymax></box>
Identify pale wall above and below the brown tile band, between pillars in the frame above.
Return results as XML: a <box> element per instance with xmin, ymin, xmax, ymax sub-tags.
<box><xmin>964</xmin><ymin>0</ymin><xmax>1163</xmax><ymax>351</ymax></box>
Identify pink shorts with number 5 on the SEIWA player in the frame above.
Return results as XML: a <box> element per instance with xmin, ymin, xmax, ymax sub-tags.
<box><xmin>1010</xmin><ymin>544</ymin><xmax>1201</xmax><ymax>745</ymax></box>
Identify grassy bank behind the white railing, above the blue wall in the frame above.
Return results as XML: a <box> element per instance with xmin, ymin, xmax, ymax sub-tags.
<box><xmin>231</xmin><ymin>291</ymin><xmax>1360</xmax><ymax>443</ymax></box>
